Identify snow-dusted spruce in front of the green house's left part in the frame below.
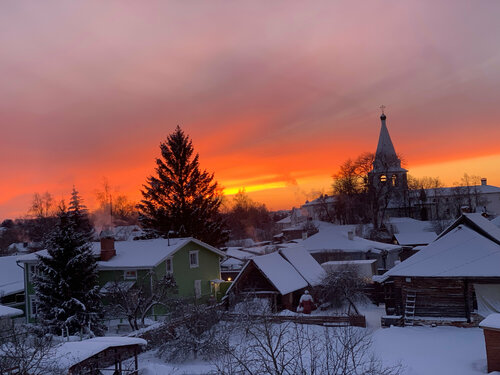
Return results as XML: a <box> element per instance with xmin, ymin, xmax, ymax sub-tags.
<box><xmin>34</xmin><ymin>206</ymin><xmax>104</xmax><ymax>335</ymax></box>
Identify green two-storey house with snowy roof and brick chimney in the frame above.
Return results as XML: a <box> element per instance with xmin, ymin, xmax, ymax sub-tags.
<box><xmin>18</xmin><ymin>237</ymin><xmax>224</xmax><ymax>322</ymax></box>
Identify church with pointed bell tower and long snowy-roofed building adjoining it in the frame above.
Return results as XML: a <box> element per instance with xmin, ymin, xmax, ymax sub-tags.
<box><xmin>301</xmin><ymin>113</ymin><xmax>500</xmax><ymax>226</ymax></box>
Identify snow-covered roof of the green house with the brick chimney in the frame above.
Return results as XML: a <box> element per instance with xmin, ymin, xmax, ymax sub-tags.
<box><xmin>17</xmin><ymin>237</ymin><xmax>225</xmax><ymax>270</ymax></box>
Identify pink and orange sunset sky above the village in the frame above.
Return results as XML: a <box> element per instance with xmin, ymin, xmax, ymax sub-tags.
<box><xmin>0</xmin><ymin>0</ymin><xmax>500</xmax><ymax>219</ymax></box>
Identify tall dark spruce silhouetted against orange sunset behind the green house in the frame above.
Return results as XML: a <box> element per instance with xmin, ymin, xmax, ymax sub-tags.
<box><xmin>138</xmin><ymin>126</ymin><xmax>227</xmax><ymax>246</ymax></box>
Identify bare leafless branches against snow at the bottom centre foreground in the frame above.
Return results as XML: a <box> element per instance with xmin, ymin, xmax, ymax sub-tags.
<box><xmin>214</xmin><ymin>317</ymin><xmax>402</xmax><ymax>375</ymax></box>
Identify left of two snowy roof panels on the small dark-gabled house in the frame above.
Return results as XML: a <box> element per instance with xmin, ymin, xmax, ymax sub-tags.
<box><xmin>251</xmin><ymin>252</ymin><xmax>308</xmax><ymax>295</ymax></box>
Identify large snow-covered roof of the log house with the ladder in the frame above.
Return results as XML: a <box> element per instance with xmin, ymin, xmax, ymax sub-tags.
<box><xmin>382</xmin><ymin>225</ymin><xmax>500</xmax><ymax>279</ymax></box>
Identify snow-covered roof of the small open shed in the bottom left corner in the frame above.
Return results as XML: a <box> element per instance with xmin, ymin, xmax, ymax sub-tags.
<box><xmin>50</xmin><ymin>337</ymin><xmax>147</xmax><ymax>368</ymax></box>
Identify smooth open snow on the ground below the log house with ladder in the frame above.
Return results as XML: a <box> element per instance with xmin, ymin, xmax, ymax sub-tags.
<box><xmin>373</xmin><ymin>327</ymin><xmax>487</xmax><ymax>375</ymax></box>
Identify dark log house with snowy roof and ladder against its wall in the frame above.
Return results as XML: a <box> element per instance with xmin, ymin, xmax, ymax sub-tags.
<box><xmin>375</xmin><ymin>214</ymin><xmax>500</xmax><ymax>325</ymax></box>
